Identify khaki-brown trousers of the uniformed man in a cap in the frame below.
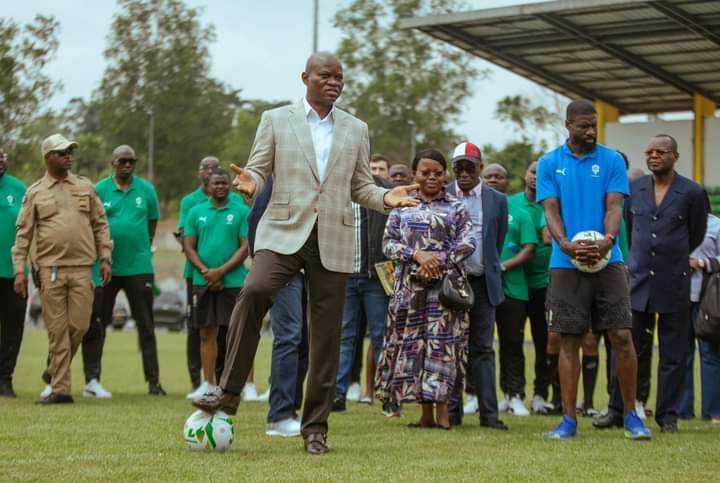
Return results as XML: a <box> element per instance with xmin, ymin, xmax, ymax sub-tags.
<box><xmin>40</xmin><ymin>267</ymin><xmax>94</xmax><ymax>395</ymax></box>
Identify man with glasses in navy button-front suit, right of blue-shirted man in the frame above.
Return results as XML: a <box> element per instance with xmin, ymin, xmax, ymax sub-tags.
<box><xmin>593</xmin><ymin>134</ymin><xmax>707</xmax><ymax>433</ymax></box>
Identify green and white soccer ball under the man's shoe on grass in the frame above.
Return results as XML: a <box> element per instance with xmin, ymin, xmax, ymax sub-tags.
<box><xmin>183</xmin><ymin>411</ymin><xmax>235</xmax><ymax>453</ymax></box>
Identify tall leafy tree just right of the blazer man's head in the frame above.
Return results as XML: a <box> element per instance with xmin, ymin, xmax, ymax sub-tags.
<box><xmin>334</xmin><ymin>0</ymin><xmax>480</xmax><ymax>163</ymax></box>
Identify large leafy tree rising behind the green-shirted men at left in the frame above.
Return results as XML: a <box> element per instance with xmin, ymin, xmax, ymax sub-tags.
<box><xmin>88</xmin><ymin>0</ymin><xmax>239</xmax><ymax>200</ymax></box>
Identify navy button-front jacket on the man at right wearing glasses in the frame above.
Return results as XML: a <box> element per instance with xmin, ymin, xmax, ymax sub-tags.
<box><xmin>625</xmin><ymin>174</ymin><xmax>707</xmax><ymax>313</ymax></box>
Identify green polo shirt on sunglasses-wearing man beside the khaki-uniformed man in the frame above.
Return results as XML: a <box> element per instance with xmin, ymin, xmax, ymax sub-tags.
<box><xmin>95</xmin><ymin>176</ymin><xmax>160</xmax><ymax>277</ymax></box>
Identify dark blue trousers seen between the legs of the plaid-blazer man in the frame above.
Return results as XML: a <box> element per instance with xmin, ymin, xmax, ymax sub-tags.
<box><xmin>267</xmin><ymin>273</ymin><xmax>308</xmax><ymax>423</ymax></box>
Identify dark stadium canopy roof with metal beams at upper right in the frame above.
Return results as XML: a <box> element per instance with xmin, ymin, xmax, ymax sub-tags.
<box><xmin>401</xmin><ymin>0</ymin><xmax>720</xmax><ymax>114</ymax></box>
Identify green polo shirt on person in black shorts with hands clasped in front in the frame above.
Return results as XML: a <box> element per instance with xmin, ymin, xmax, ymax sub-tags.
<box><xmin>185</xmin><ymin>200</ymin><xmax>250</xmax><ymax>288</ymax></box>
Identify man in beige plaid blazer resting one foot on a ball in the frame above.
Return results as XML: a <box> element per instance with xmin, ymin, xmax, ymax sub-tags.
<box><xmin>193</xmin><ymin>53</ymin><xmax>417</xmax><ymax>454</ymax></box>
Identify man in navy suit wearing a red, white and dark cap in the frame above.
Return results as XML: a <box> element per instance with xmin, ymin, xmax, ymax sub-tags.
<box><xmin>447</xmin><ymin>143</ymin><xmax>508</xmax><ymax>430</ymax></box>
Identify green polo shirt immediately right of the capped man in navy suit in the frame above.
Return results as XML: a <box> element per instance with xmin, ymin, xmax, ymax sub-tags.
<box><xmin>500</xmin><ymin>203</ymin><xmax>538</xmax><ymax>300</ymax></box>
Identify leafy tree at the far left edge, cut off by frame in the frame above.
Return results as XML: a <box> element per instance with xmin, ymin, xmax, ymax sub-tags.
<box><xmin>0</xmin><ymin>15</ymin><xmax>60</xmax><ymax>147</ymax></box>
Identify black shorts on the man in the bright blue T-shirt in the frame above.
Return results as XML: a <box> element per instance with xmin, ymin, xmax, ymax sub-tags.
<box><xmin>546</xmin><ymin>263</ymin><xmax>632</xmax><ymax>335</ymax></box>
